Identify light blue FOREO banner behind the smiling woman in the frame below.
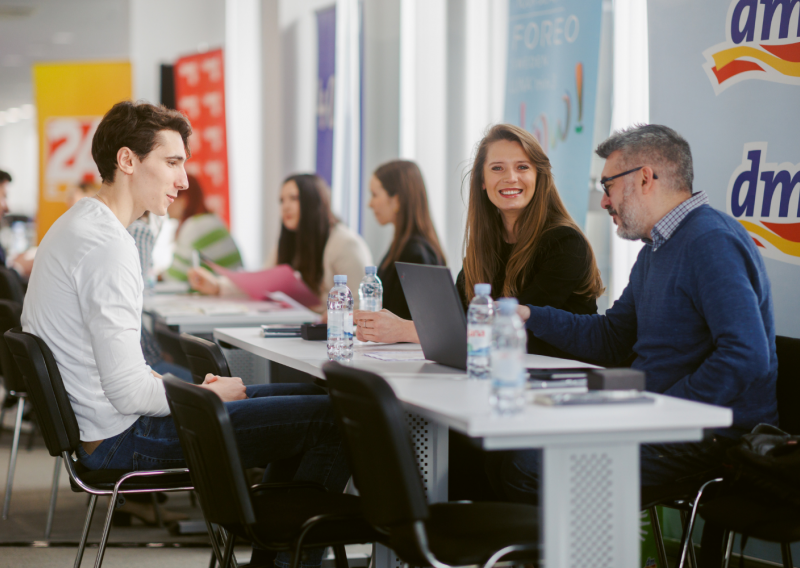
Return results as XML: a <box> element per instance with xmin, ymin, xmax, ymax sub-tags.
<box><xmin>505</xmin><ymin>0</ymin><xmax>602</xmax><ymax>231</ymax></box>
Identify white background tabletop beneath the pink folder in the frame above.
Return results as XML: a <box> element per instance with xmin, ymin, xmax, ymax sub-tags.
<box><xmin>143</xmin><ymin>294</ymin><xmax>320</xmax><ymax>333</ymax></box>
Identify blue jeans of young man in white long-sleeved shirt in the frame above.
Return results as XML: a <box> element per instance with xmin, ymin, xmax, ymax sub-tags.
<box><xmin>77</xmin><ymin>383</ymin><xmax>350</xmax><ymax>568</ymax></box>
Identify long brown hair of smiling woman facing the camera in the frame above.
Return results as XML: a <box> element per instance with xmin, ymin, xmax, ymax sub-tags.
<box><xmin>464</xmin><ymin>124</ymin><xmax>603</xmax><ymax>300</ymax></box>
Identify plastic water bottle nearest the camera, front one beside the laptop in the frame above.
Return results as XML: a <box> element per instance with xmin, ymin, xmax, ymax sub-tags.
<box><xmin>491</xmin><ymin>298</ymin><xmax>527</xmax><ymax>414</ymax></box>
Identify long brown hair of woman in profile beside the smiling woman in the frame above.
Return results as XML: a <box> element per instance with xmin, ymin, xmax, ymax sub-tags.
<box><xmin>373</xmin><ymin>160</ymin><xmax>445</xmax><ymax>270</ymax></box>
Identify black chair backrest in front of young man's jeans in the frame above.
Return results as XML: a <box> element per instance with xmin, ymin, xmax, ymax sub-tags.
<box><xmin>164</xmin><ymin>374</ymin><xmax>255</xmax><ymax>525</ymax></box>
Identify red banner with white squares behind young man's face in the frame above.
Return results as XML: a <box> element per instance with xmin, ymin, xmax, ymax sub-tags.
<box><xmin>175</xmin><ymin>49</ymin><xmax>230</xmax><ymax>226</ymax></box>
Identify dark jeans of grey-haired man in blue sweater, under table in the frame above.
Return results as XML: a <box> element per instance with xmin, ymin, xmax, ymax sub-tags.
<box><xmin>486</xmin><ymin>435</ymin><xmax>736</xmax><ymax>505</ymax></box>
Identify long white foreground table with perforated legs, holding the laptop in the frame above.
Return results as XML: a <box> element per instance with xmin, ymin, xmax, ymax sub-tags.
<box><xmin>214</xmin><ymin>328</ymin><xmax>733</xmax><ymax>568</ymax></box>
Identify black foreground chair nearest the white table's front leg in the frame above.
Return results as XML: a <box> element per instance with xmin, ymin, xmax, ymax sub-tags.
<box><xmin>323</xmin><ymin>363</ymin><xmax>539</xmax><ymax>568</ymax></box>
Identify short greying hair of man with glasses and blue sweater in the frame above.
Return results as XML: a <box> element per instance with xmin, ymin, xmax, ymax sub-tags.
<box><xmin>595</xmin><ymin>124</ymin><xmax>694</xmax><ymax>193</ymax></box>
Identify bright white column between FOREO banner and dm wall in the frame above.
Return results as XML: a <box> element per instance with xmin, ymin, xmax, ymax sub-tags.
<box><xmin>609</xmin><ymin>0</ymin><xmax>650</xmax><ymax>302</ymax></box>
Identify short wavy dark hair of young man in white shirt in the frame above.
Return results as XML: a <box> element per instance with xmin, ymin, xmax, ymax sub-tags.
<box><xmin>92</xmin><ymin>101</ymin><xmax>192</xmax><ymax>183</ymax></box>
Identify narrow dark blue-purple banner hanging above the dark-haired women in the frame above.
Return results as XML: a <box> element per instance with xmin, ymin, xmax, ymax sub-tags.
<box><xmin>317</xmin><ymin>6</ymin><xmax>336</xmax><ymax>186</ymax></box>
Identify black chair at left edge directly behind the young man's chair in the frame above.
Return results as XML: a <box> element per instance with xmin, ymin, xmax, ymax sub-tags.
<box><xmin>0</xmin><ymin>300</ymin><xmax>61</xmax><ymax>540</ymax></box>
